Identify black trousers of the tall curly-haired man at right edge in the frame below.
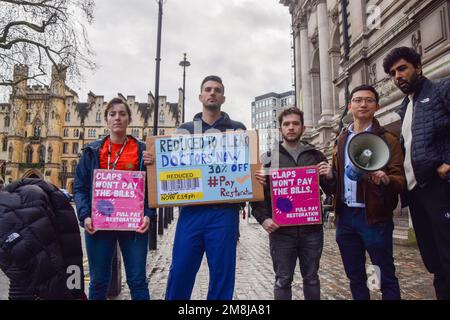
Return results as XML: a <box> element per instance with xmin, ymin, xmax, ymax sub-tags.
<box><xmin>408</xmin><ymin>178</ymin><xmax>450</xmax><ymax>300</ymax></box>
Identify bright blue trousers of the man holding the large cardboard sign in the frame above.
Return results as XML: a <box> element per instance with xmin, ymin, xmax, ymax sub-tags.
<box><xmin>166</xmin><ymin>206</ymin><xmax>239</xmax><ymax>300</ymax></box>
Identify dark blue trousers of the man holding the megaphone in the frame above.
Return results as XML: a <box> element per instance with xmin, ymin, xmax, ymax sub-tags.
<box><xmin>336</xmin><ymin>207</ymin><xmax>400</xmax><ymax>300</ymax></box>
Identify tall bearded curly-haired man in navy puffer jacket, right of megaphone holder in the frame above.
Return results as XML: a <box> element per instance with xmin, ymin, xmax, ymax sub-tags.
<box><xmin>383</xmin><ymin>47</ymin><xmax>450</xmax><ymax>300</ymax></box>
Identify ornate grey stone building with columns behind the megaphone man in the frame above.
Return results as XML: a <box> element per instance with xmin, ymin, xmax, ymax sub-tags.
<box><xmin>279</xmin><ymin>0</ymin><xmax>450</xmax><ymax>240</ymax></box>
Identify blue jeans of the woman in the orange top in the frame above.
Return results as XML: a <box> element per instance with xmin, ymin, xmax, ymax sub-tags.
<box><xmin>85</xmin><ymin>231</ymin><xmax>150</xmax><ymax>300</ymax></box>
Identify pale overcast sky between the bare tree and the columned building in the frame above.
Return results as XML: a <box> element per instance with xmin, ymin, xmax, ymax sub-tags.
<box><xmin>77</xmin><ymin>0</ymin><xmax>293</xmax><ymax>127</ymax></box>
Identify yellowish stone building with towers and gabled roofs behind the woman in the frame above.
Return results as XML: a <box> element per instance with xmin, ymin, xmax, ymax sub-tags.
<box><xmin>0</xmin><ymin>65</ymin><xmax>183</xmax><ymax>192</ymax></box>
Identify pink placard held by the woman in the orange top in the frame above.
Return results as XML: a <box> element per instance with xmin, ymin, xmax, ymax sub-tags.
<box><xmin>92</xmin><ymin>169</ymin><xmax>145</xmax><ymax>231</ymax></box>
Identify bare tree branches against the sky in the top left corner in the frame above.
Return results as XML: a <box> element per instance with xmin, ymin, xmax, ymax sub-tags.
<box><xmin>0</xmin><ymin>0</ymin><xmax>95</xmax><ymax>87</ymax></box>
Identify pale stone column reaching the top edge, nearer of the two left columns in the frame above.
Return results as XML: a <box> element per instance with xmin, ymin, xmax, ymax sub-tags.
<box><xmin>317</xmin><ymin>0</ymin><xmax>333</xmax><ymax>123</ymax></box>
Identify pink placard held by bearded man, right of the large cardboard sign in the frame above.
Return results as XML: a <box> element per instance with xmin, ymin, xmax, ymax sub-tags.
<box><xmin>270</xmin><ymin>166</ymin><xmax>322</xmax><ymax>226</ymax></box>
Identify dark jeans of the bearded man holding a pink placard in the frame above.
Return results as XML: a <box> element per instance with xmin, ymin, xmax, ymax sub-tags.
<box><xmin>269</xmin><ymin>226</ymin><xmax>323</xmax><ymax>300</ymax></box>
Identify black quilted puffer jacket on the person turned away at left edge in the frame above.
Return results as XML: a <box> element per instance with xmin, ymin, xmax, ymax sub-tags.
<box><xmin>0</xmin><ymin>179</ymin><xmax>84</xmax><ymax>299</ymax></box>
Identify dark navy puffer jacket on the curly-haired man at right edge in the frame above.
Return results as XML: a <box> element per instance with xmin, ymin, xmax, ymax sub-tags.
<box><xmin>397</xmin><ymin>77</ymin><xmax>450</xmax><ymax>185</ymax></box>
